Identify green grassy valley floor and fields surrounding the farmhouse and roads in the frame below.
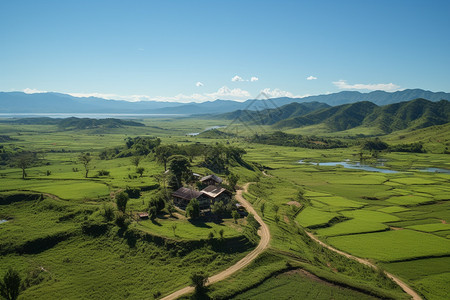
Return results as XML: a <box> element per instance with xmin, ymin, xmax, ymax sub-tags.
<box><xmin>0</xmin><ymin>118</ymin><xmax>450</xmax><ymax>299</ymax></box>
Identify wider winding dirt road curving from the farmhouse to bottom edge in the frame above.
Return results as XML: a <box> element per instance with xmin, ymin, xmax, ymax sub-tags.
<box><xmin>162</xmin><ymin>182</ymin><xmax>270</xmax><ymax>300</ymax></box>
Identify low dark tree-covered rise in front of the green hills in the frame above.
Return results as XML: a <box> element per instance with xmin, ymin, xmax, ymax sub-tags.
<box><xmin>250</xmin><ymin>131</ymin><xmax>348</xmax><ymax>149</ymax></box>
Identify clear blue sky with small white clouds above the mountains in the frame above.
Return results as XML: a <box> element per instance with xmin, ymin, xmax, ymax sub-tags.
<box><xmin>0</xmin><ymin>0</ymin><xmax>450</xmax><ymax>102</ymax></box>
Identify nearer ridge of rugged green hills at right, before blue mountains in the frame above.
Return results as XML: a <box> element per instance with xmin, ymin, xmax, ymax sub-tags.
<box><xmin>216</xmin><ymin>98</ymin><xmax>450</xmax><ymax>133</ymax></box>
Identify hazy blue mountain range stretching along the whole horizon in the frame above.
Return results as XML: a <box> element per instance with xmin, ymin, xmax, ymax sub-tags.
<box><xmin>0</xmin><ymin>89</ymin><xmax>450</xmax><ymax>114</ymax></box>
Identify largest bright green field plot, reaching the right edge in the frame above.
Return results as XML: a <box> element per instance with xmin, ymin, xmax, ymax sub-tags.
<box><xmin>328</xmin><ymin>229</ymin><xmax>450</xmax><ymax>261</ymax></box>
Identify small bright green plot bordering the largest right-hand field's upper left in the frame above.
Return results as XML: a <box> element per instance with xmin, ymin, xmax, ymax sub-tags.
<box><xmin>317</xmin><ymin>219</ymin><xmax>389</xmax><ymax>236</ymax></box>
